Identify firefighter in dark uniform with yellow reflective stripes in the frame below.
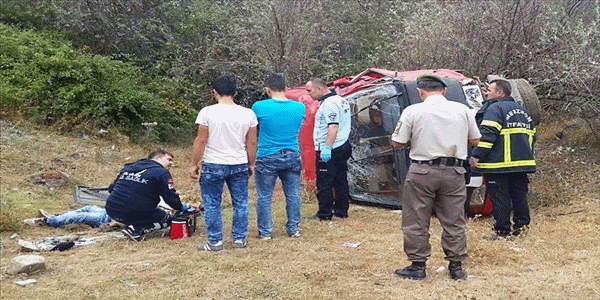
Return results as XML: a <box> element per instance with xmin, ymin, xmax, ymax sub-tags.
<box><xmin>472</xmin><ymin>79</ymin><xmax>536</xmax><ymax>240</ymax></box>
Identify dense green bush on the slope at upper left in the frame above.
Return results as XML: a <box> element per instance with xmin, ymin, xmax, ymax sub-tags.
<box><xmin>0</xmin><ymin>25</ymin><xmax>195</xmax><ymax>142</ymax></box>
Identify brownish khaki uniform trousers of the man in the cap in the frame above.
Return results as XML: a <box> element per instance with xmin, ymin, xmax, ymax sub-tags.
<box><xmin>402</xmin><ymin>163</ymin><xmax>467</xmax><ymax>262</ymax></box>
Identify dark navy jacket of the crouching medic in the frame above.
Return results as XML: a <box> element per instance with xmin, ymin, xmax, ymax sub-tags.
<box><xmin>106</xmin><ymin>159</ymin><xmax>182</xmax><ymax>213</ymax></box>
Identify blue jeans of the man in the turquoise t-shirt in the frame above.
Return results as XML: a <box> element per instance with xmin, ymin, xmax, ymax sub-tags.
<box><xmin>254</xmin><ymin>149</ymin><xmax>302</xmax><ymax>236</ymax></box>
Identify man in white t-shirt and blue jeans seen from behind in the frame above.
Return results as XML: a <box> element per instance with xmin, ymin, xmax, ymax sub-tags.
<box><xmin>190</xmin><ymin>76</ymin><xmax>258</xmax><ymax>251</ymax></box>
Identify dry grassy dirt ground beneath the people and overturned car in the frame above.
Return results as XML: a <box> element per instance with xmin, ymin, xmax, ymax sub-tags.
<box><xmin>0</xmin><ymin>120</ymin><xmax>600</xmax><ymax>300</ymax></box>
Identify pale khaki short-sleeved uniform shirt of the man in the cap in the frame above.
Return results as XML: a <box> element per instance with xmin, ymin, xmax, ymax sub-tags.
<box><xmin>392</xmin><ymin>95</ymin><xmax>481</xmax><ymax>160</ymax></box>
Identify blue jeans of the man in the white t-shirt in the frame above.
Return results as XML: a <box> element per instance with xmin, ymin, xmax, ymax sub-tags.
<box><xmin>200</xmin><ymin>164</ymin><xmax>248</xmax><ymax>244</ymax></box>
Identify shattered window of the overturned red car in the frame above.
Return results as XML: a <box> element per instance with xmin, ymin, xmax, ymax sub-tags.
<box><xmin>346</xmin><ymin>84</ymin><xmax>407</xmax><ymax>206</ymax></box>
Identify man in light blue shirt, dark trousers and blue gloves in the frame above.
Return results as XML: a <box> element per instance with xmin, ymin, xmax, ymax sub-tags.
<box><xmin>305</xmin><ymin>79</ymin><xmax>352</xmax><ymax>221</ymax></box>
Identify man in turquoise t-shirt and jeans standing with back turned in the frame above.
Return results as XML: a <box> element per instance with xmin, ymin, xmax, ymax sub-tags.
<box><xmin>252</xmin><ymin>74</ymin><xmax>304</xmax><ymax>240</ymax></box>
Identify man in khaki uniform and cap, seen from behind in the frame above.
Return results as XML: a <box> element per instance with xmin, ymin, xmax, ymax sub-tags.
<box><xmin>392</xmin><ymin>74</ymin><xmax>481</xmax><ymax>280</ymax></box>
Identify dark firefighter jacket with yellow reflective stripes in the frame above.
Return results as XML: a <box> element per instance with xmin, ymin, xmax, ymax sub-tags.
<box><xmin>473</xmin><ymin>97</ymin><xmax>536</xmax><ymax>173</ymax></box>
